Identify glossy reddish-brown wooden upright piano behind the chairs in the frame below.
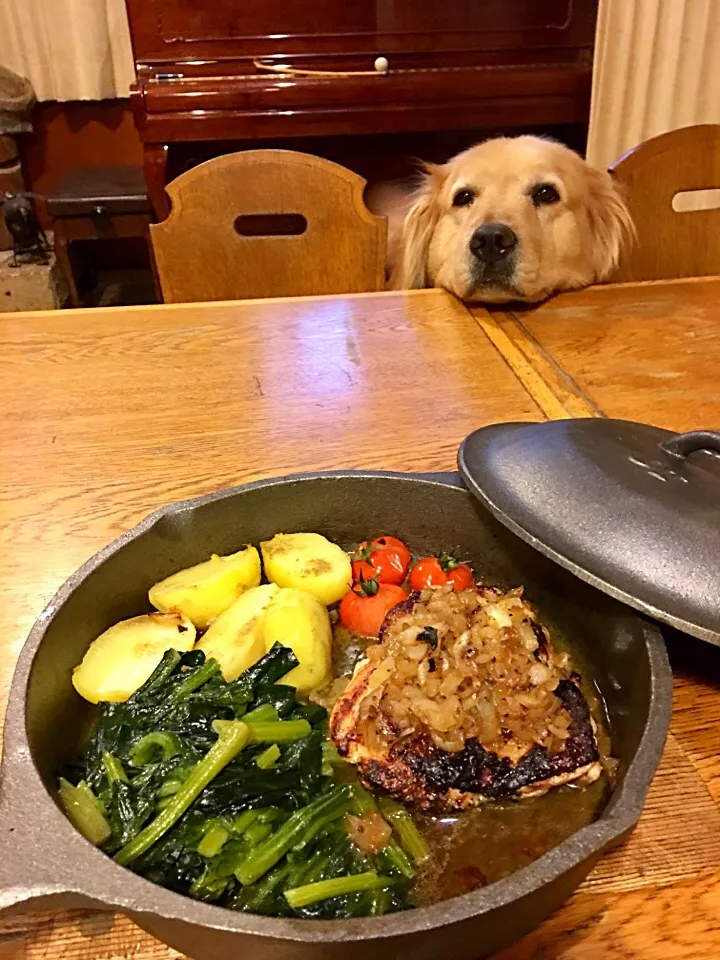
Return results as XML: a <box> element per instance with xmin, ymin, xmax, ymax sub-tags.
<box><xmin>126</xmin><ymin>0</ymin><xmax>599</xmax><ymax>218</ymax></box>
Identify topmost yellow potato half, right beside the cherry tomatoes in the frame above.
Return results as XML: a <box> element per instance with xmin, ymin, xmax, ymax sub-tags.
<box><xmin>260</xmin><ymin>533</ymin><xmax>352</xmax><ymax>606</ymax></box>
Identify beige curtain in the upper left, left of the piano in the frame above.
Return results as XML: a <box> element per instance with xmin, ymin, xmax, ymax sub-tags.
<box><xmin>0</xmin><ymin>0</ymin><xmax>134</xmax><ymax>100</ymax></box>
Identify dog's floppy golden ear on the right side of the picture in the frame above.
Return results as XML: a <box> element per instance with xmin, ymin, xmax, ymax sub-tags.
<box><xmin>585</xmin><ymin>164</ymin><xmax>635</xmax><ymax>280</ymax></box>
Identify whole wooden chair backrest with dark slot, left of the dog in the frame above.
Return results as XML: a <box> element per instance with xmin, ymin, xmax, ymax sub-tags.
<box><xmin>150</xmin><ymin>150</ymin><xmax>387</xmax><ymax>303</ymax></box>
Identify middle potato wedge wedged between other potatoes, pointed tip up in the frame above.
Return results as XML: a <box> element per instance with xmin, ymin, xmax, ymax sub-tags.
<box><xmin>197</xmin><ymin>583</ymin><xmax>280</xmax><ymax>680</ymax></box>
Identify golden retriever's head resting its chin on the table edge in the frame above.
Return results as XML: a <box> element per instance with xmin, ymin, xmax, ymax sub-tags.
<box><xmin>393</xmin><ymin>136</ymin><xmax>633</xmax><ymax>303</ymax></box>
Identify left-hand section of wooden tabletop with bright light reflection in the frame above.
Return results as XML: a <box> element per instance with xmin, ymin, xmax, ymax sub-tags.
<box><xmin>0</xmin><ymin>291</ymin><xmax>541</xmax><ymax>732</ymax></box>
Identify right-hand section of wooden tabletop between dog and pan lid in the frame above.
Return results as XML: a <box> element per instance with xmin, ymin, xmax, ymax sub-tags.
<box><xmin>477</xmin><ymin>277</ymin><xmax>720</xmax><ymax>431</ymax></box>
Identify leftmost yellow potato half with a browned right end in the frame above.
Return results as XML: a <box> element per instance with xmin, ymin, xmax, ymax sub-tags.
<box><xmin>72</xmin><ymin>613</ymin><xmax>196</xmax><ymax>703</ymax></box>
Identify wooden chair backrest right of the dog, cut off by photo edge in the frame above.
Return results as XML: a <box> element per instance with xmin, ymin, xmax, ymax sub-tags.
<box><xmin>610</xmin><ymin>124</ymin><xmax>720</xmax><ymax>280</ymax></box>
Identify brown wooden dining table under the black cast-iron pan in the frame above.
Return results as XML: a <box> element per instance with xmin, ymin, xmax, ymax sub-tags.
<box><xmin>0</xmin><ymin>278</ymin><xmax>720</xmax><ymax>960</ymax></box>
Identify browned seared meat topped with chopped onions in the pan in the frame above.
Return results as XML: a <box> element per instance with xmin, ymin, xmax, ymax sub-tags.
<box><xmin>330</xmin><ymin>585</ymin><xmax>601</xmax><ymax>811</ymax></box>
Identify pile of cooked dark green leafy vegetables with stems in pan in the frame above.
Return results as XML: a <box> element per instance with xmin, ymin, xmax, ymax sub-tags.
<box><xmin>60</xmin><ymin>646</ymin><xmax>414</xmax><ymax>919</ymax></box>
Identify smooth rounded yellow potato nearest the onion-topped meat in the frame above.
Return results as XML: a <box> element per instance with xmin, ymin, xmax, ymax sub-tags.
<box><xmin>263</xmin><ymin>587</ymin><xmax>332</xmax><ymax>693</ymax></box>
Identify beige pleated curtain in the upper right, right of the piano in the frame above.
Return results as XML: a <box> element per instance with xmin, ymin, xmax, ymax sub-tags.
<box><xmin>588</xmin><ymin>0</ymin><xmax>720</xmax><ymax>168</ymax></box>
